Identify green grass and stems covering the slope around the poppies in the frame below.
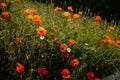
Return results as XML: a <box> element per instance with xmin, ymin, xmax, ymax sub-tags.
<box><xmin>0</xmin><ymin>0</ymin><xmax>120</xmax><ymax>80</ymax></box>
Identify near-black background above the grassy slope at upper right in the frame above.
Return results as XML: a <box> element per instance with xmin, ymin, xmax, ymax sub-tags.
<box><xmin>34</xmin><ymin>0</ymin><xmax>120</xmax><ymax>23</ymax></box>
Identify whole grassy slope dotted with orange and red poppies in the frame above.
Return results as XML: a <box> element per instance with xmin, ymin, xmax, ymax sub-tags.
<box><xmin>0</xmin><ymin>0</ymin><xmax>120</xmax><ymax>80</ymax></box>
